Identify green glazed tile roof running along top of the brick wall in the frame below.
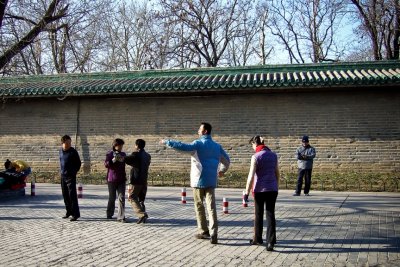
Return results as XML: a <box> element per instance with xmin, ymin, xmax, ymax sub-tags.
<box><xmin>0</xmin><ymin>61</ymin><xmax>400</xmax><ymax>98</ymax></box>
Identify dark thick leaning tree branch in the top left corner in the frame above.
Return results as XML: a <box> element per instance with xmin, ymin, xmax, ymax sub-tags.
<box><xmin>0</xmin><ymin>0</ymin><xmax>68</xmax><ymax>73</ymax></box>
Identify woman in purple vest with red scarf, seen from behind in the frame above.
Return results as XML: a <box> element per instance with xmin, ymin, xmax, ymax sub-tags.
<box><xmin>244</xmin><ymin>135</ymin><xmax>280</xmax><ymax>251</ymax></box>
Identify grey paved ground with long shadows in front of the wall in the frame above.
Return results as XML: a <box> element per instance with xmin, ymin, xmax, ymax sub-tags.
<box><xmin>0</xmin><ymin>184</ymin><xmax>400</xmax><ymax>266</ymax></box>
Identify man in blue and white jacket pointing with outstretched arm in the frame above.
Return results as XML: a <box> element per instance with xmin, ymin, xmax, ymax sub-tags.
<box><xmin>160</xmin><ymin>122</ymin><xmax>230</xmax><ymax>244</ymax></box>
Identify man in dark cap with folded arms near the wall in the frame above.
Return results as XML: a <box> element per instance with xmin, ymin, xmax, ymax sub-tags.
<box><xmin>293</xmin><ymin>135</ymin><xmax>315</xmax><ymax>196</ymax></box>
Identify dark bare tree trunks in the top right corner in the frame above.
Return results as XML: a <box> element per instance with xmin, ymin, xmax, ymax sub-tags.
<box><xmin>351</xmin><ymin>0</ymin><xmax>400</xmax><ymax>60</ymax></box>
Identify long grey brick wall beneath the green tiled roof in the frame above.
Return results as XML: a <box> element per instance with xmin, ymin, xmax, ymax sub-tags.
<box><xmin>0</xmin><ymin>89</ymin><xmax>400</xmax><ymax>176</ymax></box>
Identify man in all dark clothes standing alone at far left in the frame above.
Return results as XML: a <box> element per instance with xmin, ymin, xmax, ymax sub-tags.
<box><xmin>59</xmin><ymin>135</ymin><xmax>81</xmax><ymax>221</ymax></box>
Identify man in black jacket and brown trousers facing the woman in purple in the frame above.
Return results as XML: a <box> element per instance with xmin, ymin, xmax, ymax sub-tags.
<box><xmin>125</xmin><ymin>139</ymin><xmax>151</xmax><ymax>223</ymax></box>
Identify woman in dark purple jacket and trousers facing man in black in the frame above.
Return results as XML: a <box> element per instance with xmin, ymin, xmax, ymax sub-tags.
<box><xmin>104</xmin><ymin>138</ymin><xmax>126</xmax><ymax>223</ymax></box>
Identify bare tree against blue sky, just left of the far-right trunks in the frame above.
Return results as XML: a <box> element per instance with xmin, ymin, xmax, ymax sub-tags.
<box><xmin>269</xmin><ymin>0</ymin><xmax>344</xmax><ymax>63</ymax></box>
